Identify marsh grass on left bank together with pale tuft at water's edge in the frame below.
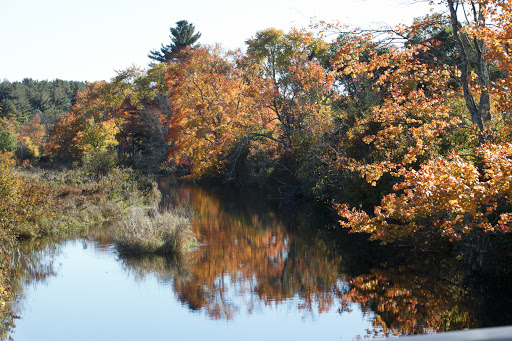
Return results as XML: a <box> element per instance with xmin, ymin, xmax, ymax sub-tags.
<box><xmin>15</xmin><ymin>162</ymin><xmax>193</xmax><ymax>256</ymax></box>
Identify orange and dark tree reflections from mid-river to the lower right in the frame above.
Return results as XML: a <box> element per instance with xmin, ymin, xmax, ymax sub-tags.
<box><xmin>154</xmin><ymin>181</ymin><xmax>510</xmax><ymax>337</ymax></box>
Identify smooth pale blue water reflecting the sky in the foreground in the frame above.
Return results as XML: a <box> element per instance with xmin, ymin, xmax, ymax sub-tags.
<box><xmin>12</xmin><ymin>241</ymin><xmax>368</xmax><ymax>340</ymax></box>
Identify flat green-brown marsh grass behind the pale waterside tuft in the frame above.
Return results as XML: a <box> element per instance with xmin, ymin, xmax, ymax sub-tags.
<box><xmin>24</xmin><ymin>168</ymin><xmax>160</xmax><ymax>234</ymax></box>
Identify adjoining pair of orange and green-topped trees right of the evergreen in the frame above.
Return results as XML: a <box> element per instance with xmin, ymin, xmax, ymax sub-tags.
<box><xmin>166</xmin><ymin>29</ymin><xmax>335</xmax><ymax>183</ymax></box>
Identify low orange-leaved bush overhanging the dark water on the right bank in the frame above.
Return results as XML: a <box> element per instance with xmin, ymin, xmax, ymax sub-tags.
<box><xmin>335</xmin><ymin>143</ymin><xmax>512</xmax><ymax>242</ymax></box>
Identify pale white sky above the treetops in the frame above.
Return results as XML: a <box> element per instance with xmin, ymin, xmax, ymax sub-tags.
<box><xmin>0</xmin><ymin>0</ymin><xmax>436</xmax><ymax>82</ymax></box>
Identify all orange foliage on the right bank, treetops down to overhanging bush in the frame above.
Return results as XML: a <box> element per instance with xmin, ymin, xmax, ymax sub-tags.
<box><xmin>326</xmin><ymin>0</ymin><xmax>512</xmax><ymax>241</ymax></box>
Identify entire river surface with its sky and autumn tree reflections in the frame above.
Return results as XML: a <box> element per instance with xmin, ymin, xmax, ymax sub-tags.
<box><xmin>10</xmin><ymin>179</ymin><xmax>512</xmax><ymax>341</ymax></box>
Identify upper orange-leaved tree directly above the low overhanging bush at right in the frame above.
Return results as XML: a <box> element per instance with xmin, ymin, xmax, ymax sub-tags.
<box><xmin>331</xmin><ymin>26</ymin><xmax>461</xmax><ymax>185</ymax></box>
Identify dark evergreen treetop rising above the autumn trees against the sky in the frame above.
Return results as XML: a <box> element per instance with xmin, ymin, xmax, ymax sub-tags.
<box><xmin>148</xmin><ymin>20</ymin><xmax>201</xmax><ymax>64</ymax></box>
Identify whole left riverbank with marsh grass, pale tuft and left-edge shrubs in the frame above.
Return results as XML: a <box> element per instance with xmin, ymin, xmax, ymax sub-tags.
<box><xmin>0</xmin><ymin>163</ymin><xmax>192</xmax><ymax>339</ymax></box>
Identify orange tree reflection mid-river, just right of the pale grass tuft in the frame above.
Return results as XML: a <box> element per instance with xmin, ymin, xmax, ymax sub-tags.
<box><xmin>133</xmin><ymin>181</ymin><xmax>346</xmax><ymax>320</ymax></box>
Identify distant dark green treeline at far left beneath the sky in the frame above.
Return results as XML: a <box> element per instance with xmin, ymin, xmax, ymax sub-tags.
<box><xmin>0</xmin><ymin>78</ymin><xmax>86</xmax><ymax>127</ymax></box>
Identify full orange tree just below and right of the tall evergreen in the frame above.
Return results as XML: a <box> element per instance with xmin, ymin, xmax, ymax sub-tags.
<box><xmin>166</xmin><ymin>47</ymin><xmax>278</xmax><ymax>178</ymax></box>
